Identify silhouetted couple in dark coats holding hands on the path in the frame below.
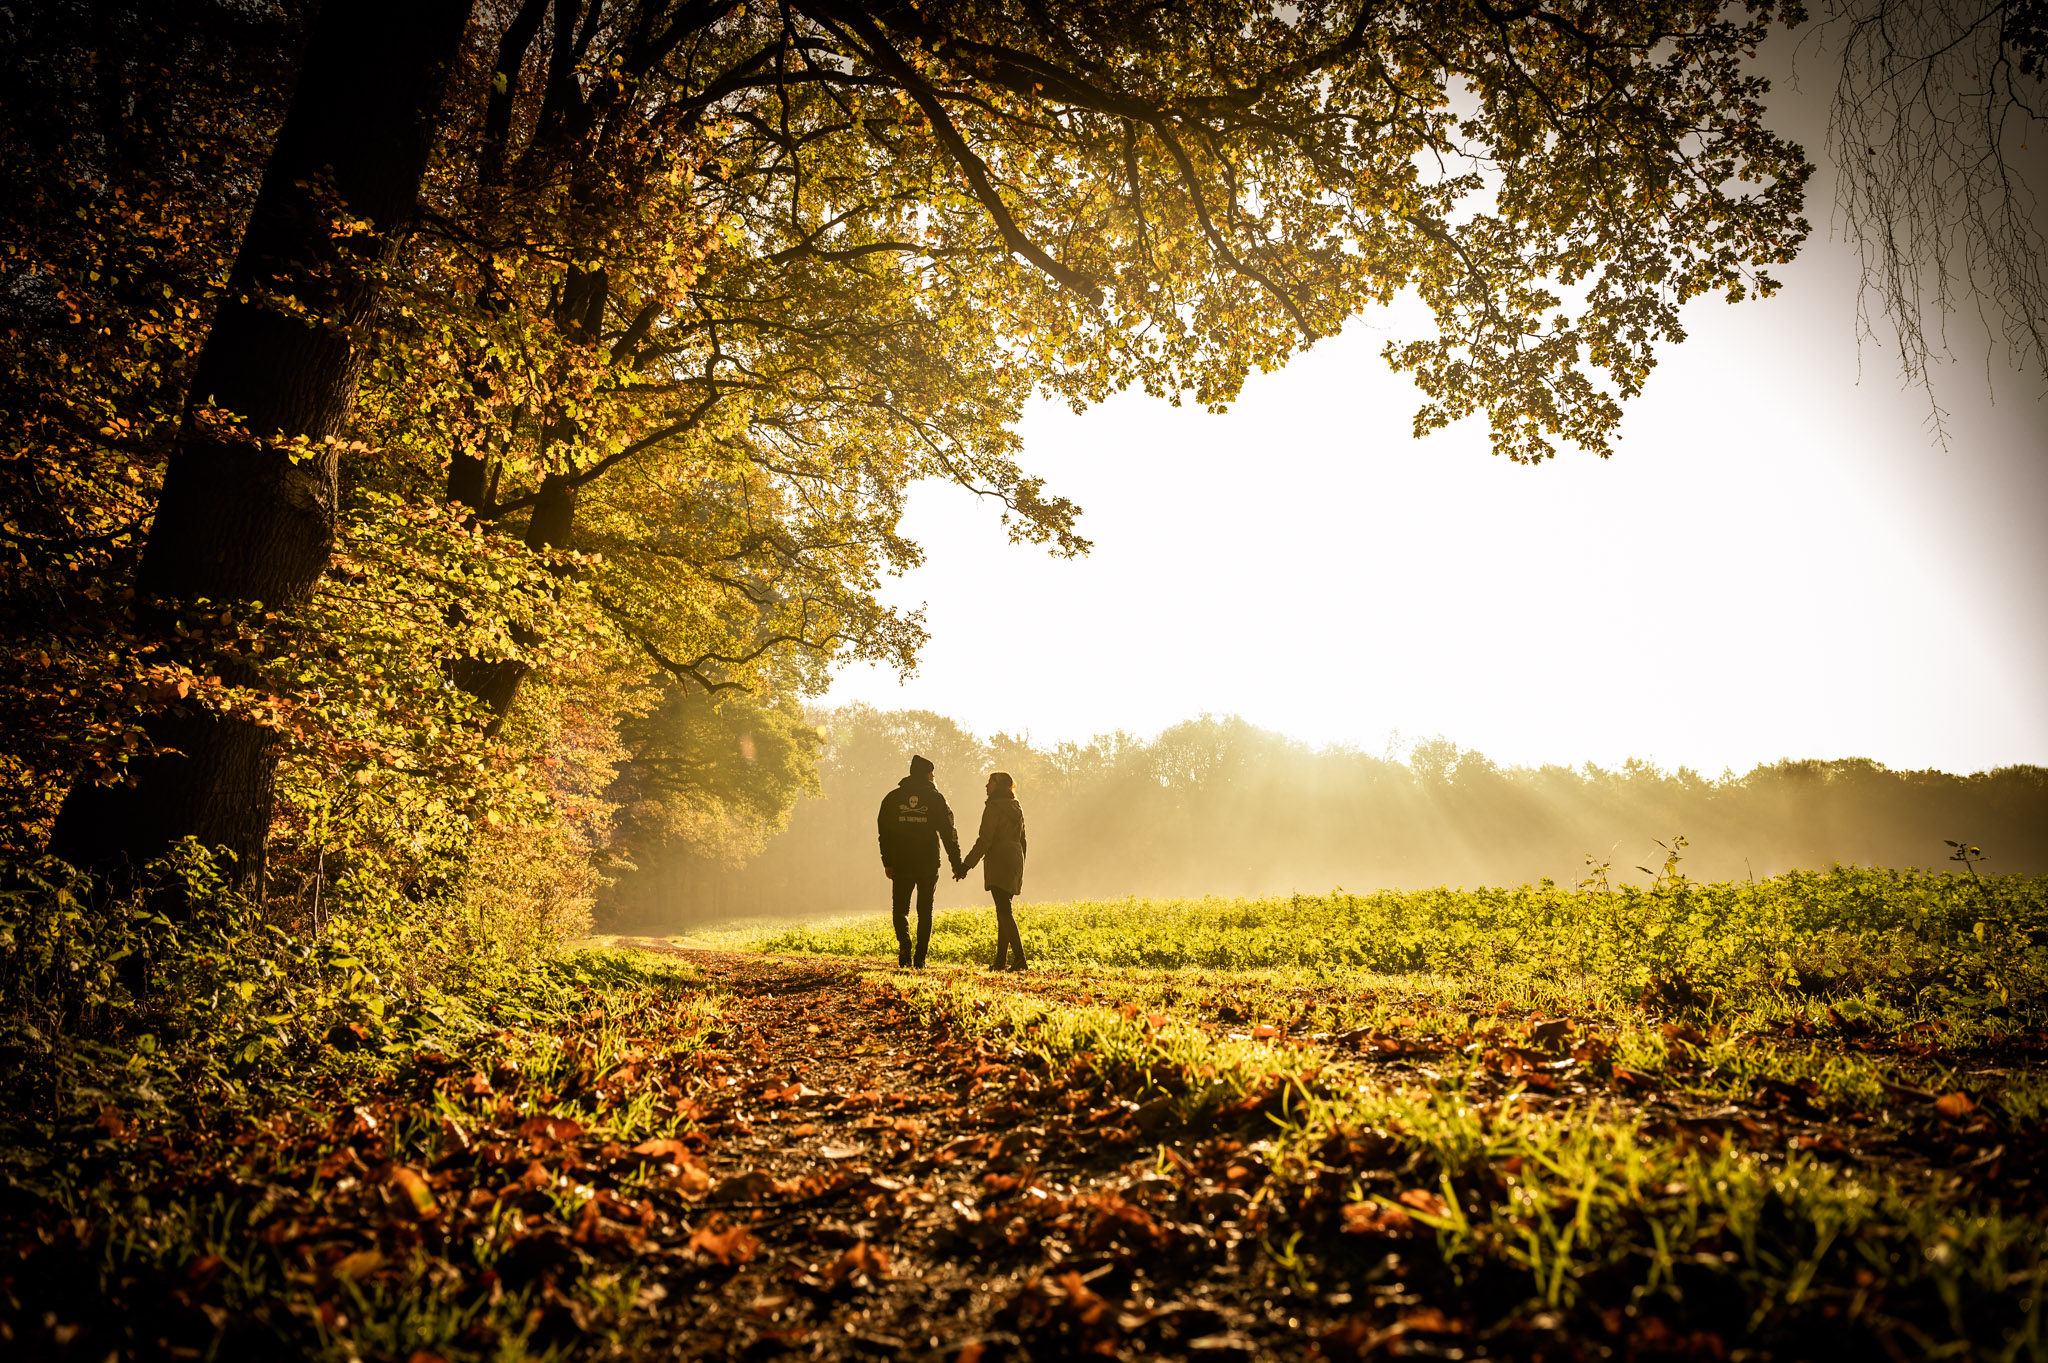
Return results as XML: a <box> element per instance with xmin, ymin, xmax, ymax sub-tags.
<box><xmin>874</xmin><ymin>757</ymin><xmax>1024</xmax><ymax>970</ymax></box>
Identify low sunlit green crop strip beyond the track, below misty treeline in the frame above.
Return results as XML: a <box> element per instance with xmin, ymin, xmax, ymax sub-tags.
<box><xmin>752</xmin><ymin>858</ymin><xmax>2048</xmax><ymax>1027</ymax></box>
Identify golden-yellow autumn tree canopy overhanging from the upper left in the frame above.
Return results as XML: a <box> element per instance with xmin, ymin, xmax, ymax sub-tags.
<box><xmin>4</xmin><ymin>0</ymin><xmax>1806</xmax><ymax>929</ymax></box>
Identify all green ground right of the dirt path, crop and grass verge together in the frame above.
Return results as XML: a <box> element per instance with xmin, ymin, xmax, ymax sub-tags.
<box><xmin>749</xmin><ymin>866</ymin><xmax>2048</xmax><ymax>1357</ymax></box>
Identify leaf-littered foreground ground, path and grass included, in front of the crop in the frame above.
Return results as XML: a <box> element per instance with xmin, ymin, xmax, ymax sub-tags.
<box><xmin>0</xmin><ymin>943</ymin><xmax>2044</xmax><ymax>1363</ymax></box>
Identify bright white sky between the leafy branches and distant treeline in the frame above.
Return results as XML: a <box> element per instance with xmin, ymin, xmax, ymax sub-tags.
<box><xmin>825</xmin><ymin>55</ymin><xmax>2048</xmax><ymax>776</ymax></box>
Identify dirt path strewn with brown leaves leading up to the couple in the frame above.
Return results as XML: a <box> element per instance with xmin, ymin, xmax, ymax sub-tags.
<box><xmin>621</xmin><ymin>941</ymin><xmax>1310</xmax><ymax>1363</ymax></box>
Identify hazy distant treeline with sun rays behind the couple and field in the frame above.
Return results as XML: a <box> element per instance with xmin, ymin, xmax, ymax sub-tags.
<box><xmin>602</xmin><ymin>706</ymin><xmax>2048</xmax><ymax>927</ymax></box>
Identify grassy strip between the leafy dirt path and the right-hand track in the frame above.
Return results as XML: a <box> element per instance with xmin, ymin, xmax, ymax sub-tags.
<box><xmin>907</xmin><ymin>976</ymin><xmax>2048</xmax><ymax>1359</ymax></box>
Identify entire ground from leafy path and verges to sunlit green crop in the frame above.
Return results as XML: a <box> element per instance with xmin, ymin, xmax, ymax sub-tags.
<box><xmin>0</xmin><ymin>864</ymin><xmax>2048</xmax><ymax>1363</ymax></box>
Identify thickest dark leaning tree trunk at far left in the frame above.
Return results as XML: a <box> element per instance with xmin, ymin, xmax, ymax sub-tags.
<box><xmin>51</xmin><ymin>0</ymin><xmax>471</xmax><ymax>884</ymax></box>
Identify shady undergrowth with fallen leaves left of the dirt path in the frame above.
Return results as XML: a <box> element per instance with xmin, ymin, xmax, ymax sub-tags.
<box><xmin>0</xmin><ymin>862</ymin><xmax>715</xmax><ymax>1361</ymax></box>
